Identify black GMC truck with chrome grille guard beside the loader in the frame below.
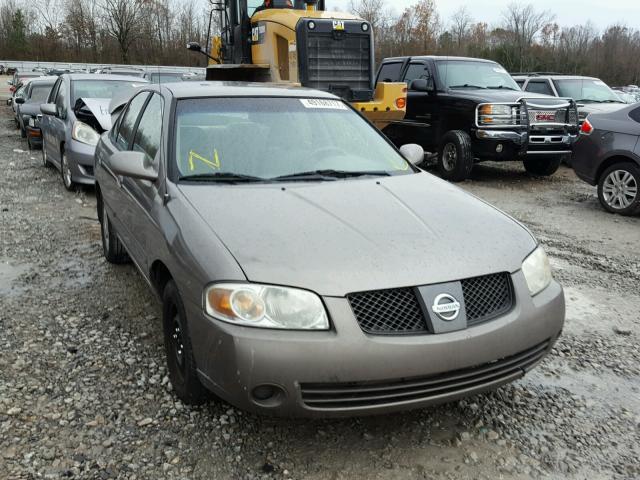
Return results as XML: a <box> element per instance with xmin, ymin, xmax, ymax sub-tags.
<box><xmin>377</xmin><ymin>56</ymin><xmax>579</xmax><ymax>181</ymax></box>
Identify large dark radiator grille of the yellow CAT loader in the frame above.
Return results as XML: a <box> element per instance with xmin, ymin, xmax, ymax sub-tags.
<box><xmin>304</xmin><ymin>32</ymin><xmax>372</xmax><ymax>91</ymax></box>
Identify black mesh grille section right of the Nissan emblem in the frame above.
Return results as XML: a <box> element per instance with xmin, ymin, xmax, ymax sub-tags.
<box><xmin>461</xmin><ymin>273</ymin><xmax>513</xmax><ymax>327</ymax></box>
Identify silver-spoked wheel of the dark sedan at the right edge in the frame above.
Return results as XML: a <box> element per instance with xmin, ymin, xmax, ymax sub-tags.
<box><xmin>598</xmin><ymin>162</ymin><xmax>640</xmax><ymax>215</ymax></box>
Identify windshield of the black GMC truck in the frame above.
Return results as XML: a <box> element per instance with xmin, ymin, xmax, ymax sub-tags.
<box><xmin>436</xmin><ymin>60</ymin><xmax>520</xmax><ymax>90</ymax></box>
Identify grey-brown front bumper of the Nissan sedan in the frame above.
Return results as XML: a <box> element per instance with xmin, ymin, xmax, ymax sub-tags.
<box><xmin>185</xmin><ymin>272</ymin><xmax>565</xmax><ymax>417</ymax></box>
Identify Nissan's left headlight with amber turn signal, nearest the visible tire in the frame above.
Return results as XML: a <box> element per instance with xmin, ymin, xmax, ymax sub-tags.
<box><xmin>205</xmin><ymin>283</ymin><xmax>329</xmax><ymax>330</ymax></box>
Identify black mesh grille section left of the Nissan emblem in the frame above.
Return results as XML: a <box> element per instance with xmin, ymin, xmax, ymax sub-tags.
<box><xmin>348</xmin><ymin>288</ymin><xmax>428</xmax><ymax>334</ymax></box>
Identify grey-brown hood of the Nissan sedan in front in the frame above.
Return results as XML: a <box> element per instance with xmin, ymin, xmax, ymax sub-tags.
<box><xmin>179</xmin><ymin>173</ymin><xmax>535</xmax><ymax>296</ymax></box>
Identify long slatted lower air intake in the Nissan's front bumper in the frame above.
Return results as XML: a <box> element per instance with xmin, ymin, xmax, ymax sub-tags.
<box><xmin>300</xmin><ymin>340</ymin><xmax>550</xmax><ymax>410</ymax></box>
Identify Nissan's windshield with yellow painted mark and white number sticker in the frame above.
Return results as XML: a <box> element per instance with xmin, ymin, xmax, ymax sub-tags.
<box><xmin>175</xmin><ymin>98</ymin><xmax>413</xmax><ymax>180</ymax></box>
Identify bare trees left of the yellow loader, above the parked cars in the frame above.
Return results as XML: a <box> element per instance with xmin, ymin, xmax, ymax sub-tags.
<box><xmin>0</xmin><ymin>0</ymin><xmax>215</xmax><ymax>66</ymax></box>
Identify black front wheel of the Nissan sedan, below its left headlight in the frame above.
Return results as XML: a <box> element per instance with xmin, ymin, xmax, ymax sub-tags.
<box><xmin>162</xmin><ymin>280</ymin><xmax>208</xmax><ymax>405</ymax></box>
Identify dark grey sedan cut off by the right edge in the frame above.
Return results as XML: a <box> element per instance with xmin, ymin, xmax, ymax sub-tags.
<box><xmin>572</xmin><ymin>104</ymin><xmax>640</xmax><ymax>215</ymax></box>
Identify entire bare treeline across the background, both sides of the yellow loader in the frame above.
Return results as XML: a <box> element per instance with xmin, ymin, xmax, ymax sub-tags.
<box><xmin>0</xmin><ymin>0</ymin><xmax>640</xmax><ymax>85</ymax></box>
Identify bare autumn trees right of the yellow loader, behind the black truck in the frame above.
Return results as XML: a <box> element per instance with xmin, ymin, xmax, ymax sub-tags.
<box><xmin>351</xmin><ymin>0</ymin><xmax>640</xmax><ymax>85</ymax></box>
